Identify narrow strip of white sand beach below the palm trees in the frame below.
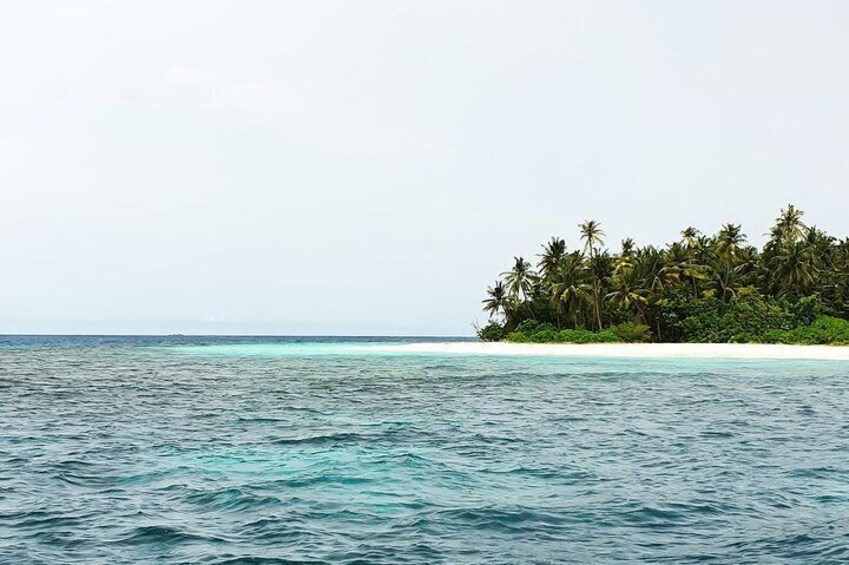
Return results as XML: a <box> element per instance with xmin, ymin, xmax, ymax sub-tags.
<box><xmin>386</xmin><ymin>341</ymin><xmax>849</xmax><ymax>361</ymax></box>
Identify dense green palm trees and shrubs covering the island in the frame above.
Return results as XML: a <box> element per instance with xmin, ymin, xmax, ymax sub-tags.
<box><xmin>478</xmin><ymin>205</ymin><xmax>849</xmax><ymax>343</ymax></box>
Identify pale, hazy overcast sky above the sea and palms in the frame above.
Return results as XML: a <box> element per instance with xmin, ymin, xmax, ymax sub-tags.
<box><xmin>0</xmin><ymin>0</ymin><xmax>849</xmax><ymax>335</ymax></box>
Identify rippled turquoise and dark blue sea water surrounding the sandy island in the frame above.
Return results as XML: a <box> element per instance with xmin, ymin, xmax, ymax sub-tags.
<box><xmin>0</xmin><ymin>337</ymin><xmax>849</xmax><ymax>564</ymax></box>
